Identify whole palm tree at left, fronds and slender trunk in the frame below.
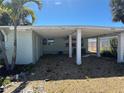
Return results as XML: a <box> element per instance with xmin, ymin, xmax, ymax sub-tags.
<box><xmin>0</xmin><ymin>0</ymin><xmax>41</xmax><ymax>70</ymax></box>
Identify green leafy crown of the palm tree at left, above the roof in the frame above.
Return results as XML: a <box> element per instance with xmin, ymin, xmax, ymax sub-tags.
<box><xmin>0</xmin><ymin>0</ymin><xmax>42</xmax><ymax>25</ymax></box>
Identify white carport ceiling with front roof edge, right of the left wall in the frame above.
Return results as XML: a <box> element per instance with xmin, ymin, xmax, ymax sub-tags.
<box><xmin>33</xmin><ymin>26</ymin><xmax>124</xmax><ymax>38</ymax></box>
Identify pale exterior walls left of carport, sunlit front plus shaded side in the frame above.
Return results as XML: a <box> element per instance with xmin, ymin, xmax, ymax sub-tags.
<box><xmin>5</xmin><ymin>31</ymin><xmax>43</xmax><ymax>64</ymax></box>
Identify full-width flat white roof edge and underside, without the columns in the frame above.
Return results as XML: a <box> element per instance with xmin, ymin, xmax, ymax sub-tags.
<box><xmin>0</xmin><ymin>26</ymin><xmax>124</xmax><ymax>38</ymax></box>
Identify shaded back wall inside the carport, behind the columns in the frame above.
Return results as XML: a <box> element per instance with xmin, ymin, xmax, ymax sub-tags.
<box><xmin>43</xmin><ymin>38</ymin><xmax>88</xmax><ymax>54</ymax></box>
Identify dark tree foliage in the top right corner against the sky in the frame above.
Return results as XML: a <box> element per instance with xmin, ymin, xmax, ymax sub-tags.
<box><xmin>110</xmin><ymin>0</ymin><xmax>124</xmax><ymax>23</ymax></box>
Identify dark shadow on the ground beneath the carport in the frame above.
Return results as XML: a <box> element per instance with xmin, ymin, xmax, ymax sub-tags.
<box><xmin>29</xmin><ymin>55</ymin><xmax>124</xmax><ymax>81</ymax></box>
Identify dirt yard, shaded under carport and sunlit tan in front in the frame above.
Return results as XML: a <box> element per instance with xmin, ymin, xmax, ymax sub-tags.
<box><xmin>4</xmin><ymin>55</ymin><xmax>124</xmax><ymax>93</ymax></box>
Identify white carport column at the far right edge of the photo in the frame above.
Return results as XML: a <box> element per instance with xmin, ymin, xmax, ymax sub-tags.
<box><xmin>117</xmin><ymin>33</ymin><xmax>124</xmax><ymax>63</ymax></box>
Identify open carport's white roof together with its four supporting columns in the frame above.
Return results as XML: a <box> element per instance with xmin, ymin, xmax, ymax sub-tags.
<box><xmin>30</xmin><ymin>26</ymin><xmax>124</xmax><ymax>65</ymax></box>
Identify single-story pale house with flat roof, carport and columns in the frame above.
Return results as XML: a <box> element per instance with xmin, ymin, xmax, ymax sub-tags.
<box><xmin>0</xmin><ymin>26</ymin><xmax>124</xmax><ymax>65</ymax></box>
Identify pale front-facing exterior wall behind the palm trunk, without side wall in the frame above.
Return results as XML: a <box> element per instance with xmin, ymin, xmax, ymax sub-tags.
<box><xmin>5</xmin><ymin>31</ymin><xmax>33</xmax><ymax>64</ymax></box>
